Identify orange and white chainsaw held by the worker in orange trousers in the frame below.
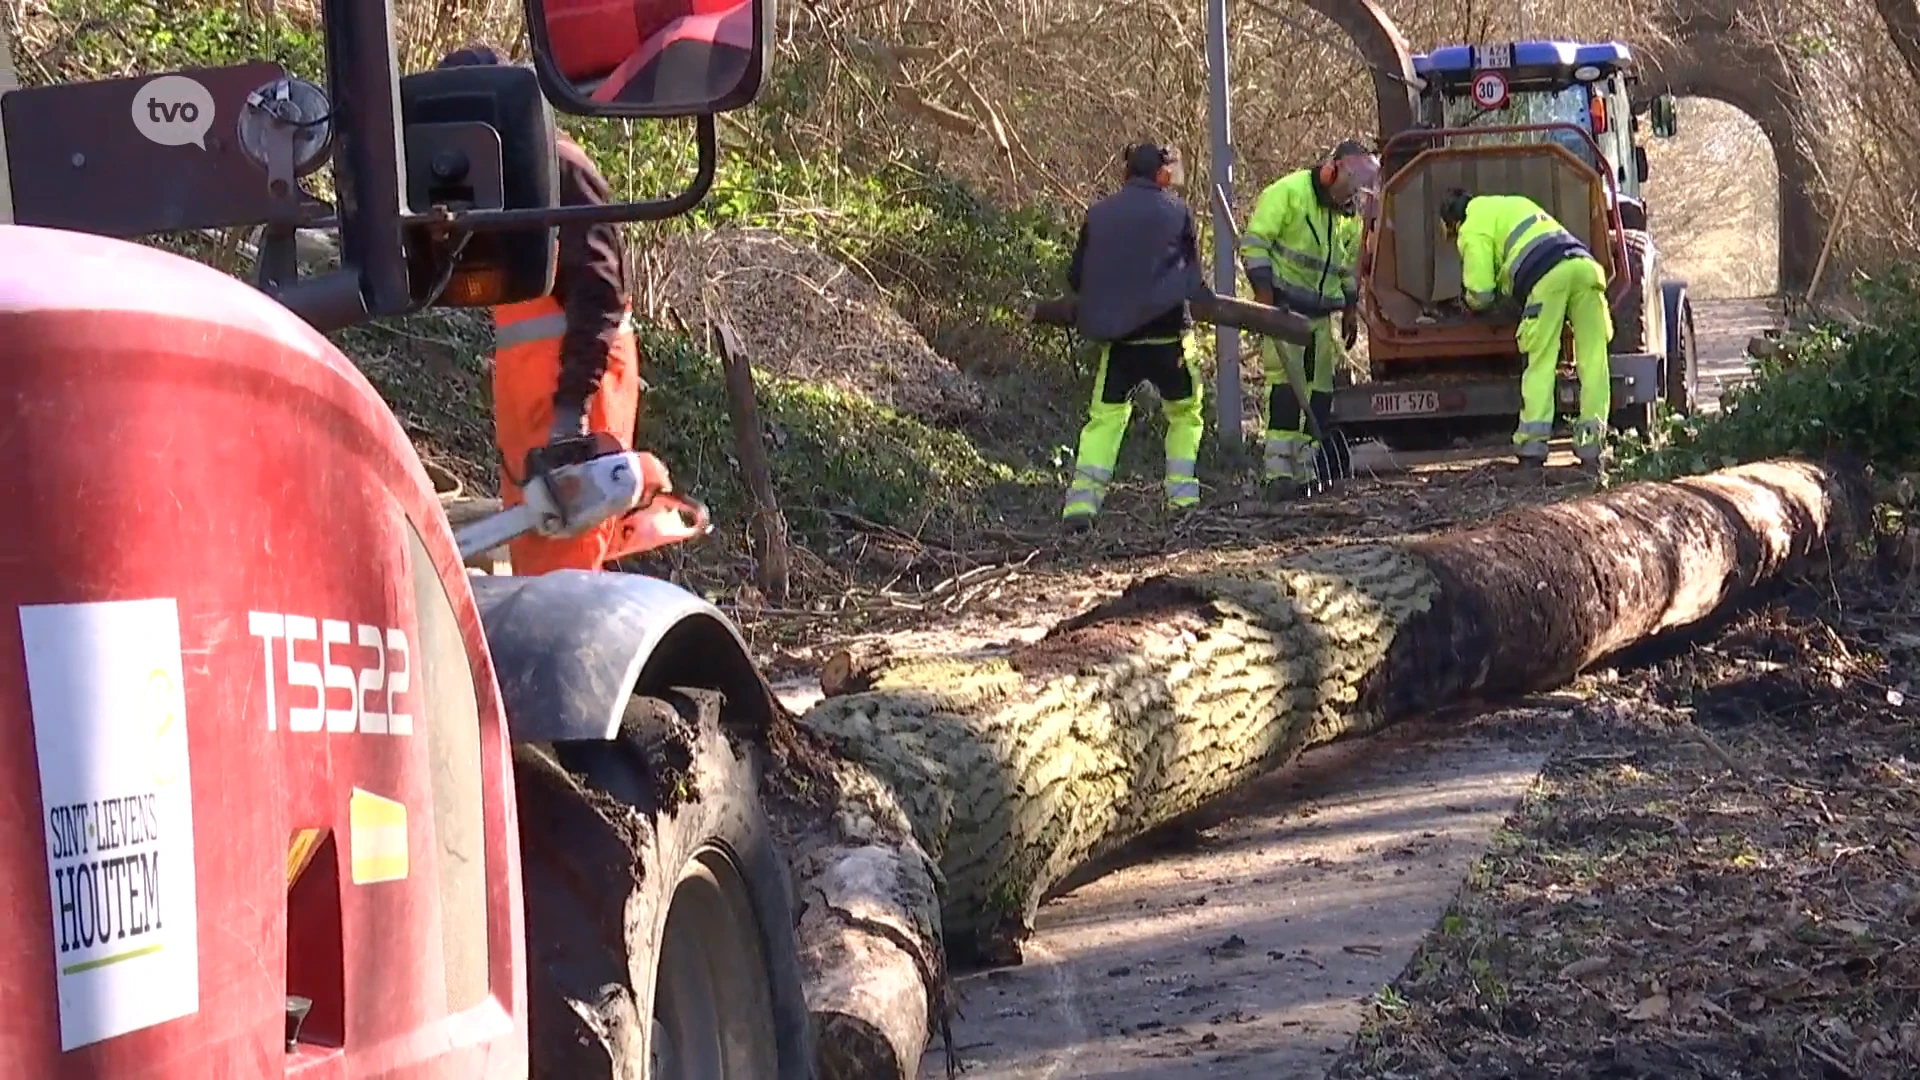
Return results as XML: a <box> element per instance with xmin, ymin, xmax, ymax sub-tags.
<box><xmin>453</xmin><ymin>432</ymin><xmax>712</xmax><ymax>561</ymax></box>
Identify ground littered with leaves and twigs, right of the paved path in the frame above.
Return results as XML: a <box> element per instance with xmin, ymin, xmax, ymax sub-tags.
<box><xmin>1331</xmin><ymin>569</ymin><xmax>1920</xmax><ymax>1080</ymax></box>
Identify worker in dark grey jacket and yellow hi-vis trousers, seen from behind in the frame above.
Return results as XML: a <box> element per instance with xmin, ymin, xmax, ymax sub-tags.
<box><xmin>1062</xmin><ymin>142</ymin><xmax>1212</xmax><ymax>528</ymax></box>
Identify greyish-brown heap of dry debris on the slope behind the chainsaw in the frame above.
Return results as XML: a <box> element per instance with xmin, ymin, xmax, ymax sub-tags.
<box><xmin>647</xmin><ymin>229</ymin><xmax>985</xmax><ymax>423</ymax></box>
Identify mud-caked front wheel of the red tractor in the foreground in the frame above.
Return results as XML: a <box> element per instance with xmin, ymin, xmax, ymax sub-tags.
<box><xmin>515</xmin><ymin>688</ymin><xmax>814</xmax><ymax>1080</ymax></box>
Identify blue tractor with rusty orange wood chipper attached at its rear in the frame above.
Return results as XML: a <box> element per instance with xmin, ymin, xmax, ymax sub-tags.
<box><xmin>1332</xmin><ymin>42</ymin><xmax>1697</xmax><ymax>450</ymax></box>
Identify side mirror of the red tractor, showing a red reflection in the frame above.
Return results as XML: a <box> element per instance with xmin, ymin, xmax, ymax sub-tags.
<box><xmin>526</xmin><ymin>0</ymin><xmax>774</xmax><ymax>119</ymax></box>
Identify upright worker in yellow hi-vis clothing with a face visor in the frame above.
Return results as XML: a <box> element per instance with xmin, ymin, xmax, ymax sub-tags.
<box><xmin>1240</xmin><ymin>140</ymin><xmax>1380</xmax><ymax>498</ymax></box>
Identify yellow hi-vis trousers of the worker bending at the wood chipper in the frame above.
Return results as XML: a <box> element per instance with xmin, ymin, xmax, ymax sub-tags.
<box><xmin>1513</xmin><ymin>258</ymin><xmax>1613</xmax><ymax>463</ymax></box>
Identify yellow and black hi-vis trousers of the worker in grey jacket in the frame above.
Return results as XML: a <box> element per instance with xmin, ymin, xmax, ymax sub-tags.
<box><xmin>1060</xmin><ymin>334</ymin><xmax>1204</xmax><ymax>517</ymax></box>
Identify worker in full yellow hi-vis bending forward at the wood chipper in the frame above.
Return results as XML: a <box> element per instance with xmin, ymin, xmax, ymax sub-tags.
<box><xmin>1440</xmin><ymin>188</ymin><xmax>1613</xmax><ymax>467</ymax></box>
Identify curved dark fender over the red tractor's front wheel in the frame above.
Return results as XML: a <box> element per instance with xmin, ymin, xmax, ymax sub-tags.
<box><xmin>468</xmin><ymin>571</ymin><xmax>778</xmax><ymax>742</ymax></box>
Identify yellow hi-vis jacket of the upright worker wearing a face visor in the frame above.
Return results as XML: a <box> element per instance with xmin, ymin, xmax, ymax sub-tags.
<box><xmin>1240</xmin><ymin>169</ymin><xmax>1359</xmax><ymax>315</ymax></box>
